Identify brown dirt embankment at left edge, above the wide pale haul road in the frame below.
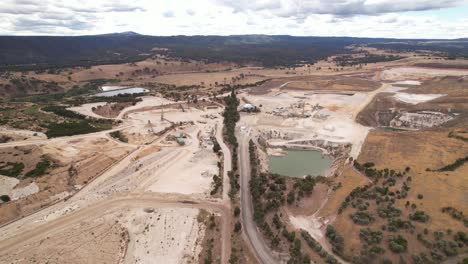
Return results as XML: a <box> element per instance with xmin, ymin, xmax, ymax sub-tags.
<box><xmin>0</xmin><ymin>139</ymin><xmax>131</xmax><ymax>224</ymax></box>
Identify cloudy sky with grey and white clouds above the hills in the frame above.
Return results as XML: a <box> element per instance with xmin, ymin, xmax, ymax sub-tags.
<box><xmin>0</xmin><ymin>0</ymin><xmax>468</xmax><ymax>38</ymax></box>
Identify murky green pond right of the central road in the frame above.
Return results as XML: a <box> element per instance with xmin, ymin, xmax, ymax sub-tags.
<box><xmin>268</xmin><ymin>150</ymin><xmax>332</xmax><ymax>177</ymax></box>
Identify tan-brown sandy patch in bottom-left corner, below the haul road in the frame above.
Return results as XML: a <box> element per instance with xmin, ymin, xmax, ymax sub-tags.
<box><xmin>0</xmin><ymin>218</ymin><xmax>127</xmax><ymax>264</ymax></box>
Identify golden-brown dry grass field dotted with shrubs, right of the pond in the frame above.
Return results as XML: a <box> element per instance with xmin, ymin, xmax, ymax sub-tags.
<box><xmin>330</xmin><ymin>129</ymin><xmax>468</xmax><ymax>263</ymax></box>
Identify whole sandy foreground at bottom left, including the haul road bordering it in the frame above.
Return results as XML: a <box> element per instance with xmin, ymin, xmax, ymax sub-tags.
<box><xmin>0</xmin><ymin>194</ymin><xmax>225</xmax><ymax>263</ymax></box>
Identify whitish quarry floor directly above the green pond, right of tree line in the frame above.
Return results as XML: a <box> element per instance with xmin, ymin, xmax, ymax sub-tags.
<box><xmin>247</xmin><ymin>92</ymin><xmax>370</xmax><ymax>158</ymax></box>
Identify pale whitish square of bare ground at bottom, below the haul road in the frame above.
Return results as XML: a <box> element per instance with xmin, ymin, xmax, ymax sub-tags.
<box><xmin>123</xmin><ymin>208</ymin><xmax>204</xmax><ymax>264</ymax></box>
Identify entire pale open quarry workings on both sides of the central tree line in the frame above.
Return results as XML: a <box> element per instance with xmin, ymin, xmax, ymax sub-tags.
<box><xmin>0</xmin><ymin>64</ymin><xmax>467</xmax><ymax>263</ymax></box>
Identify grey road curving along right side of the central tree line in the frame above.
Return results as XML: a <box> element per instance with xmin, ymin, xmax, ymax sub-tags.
<box><xmin>237</xmin><ymin>133</ymin><xmax>278</xmax><ymax>264</ymax></box>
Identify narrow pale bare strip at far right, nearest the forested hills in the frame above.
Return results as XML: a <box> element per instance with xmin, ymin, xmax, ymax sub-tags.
<box><xmin>381</xmin><ymin>67</ymin><xmax>468</xmax><ymax>81</ymax></box>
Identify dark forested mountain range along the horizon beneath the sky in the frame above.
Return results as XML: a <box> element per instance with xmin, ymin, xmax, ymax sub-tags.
<box><xmin>0</xmin><ymin>32</ymin><xmax>468</xmax><ymax>69</ymax></box>
